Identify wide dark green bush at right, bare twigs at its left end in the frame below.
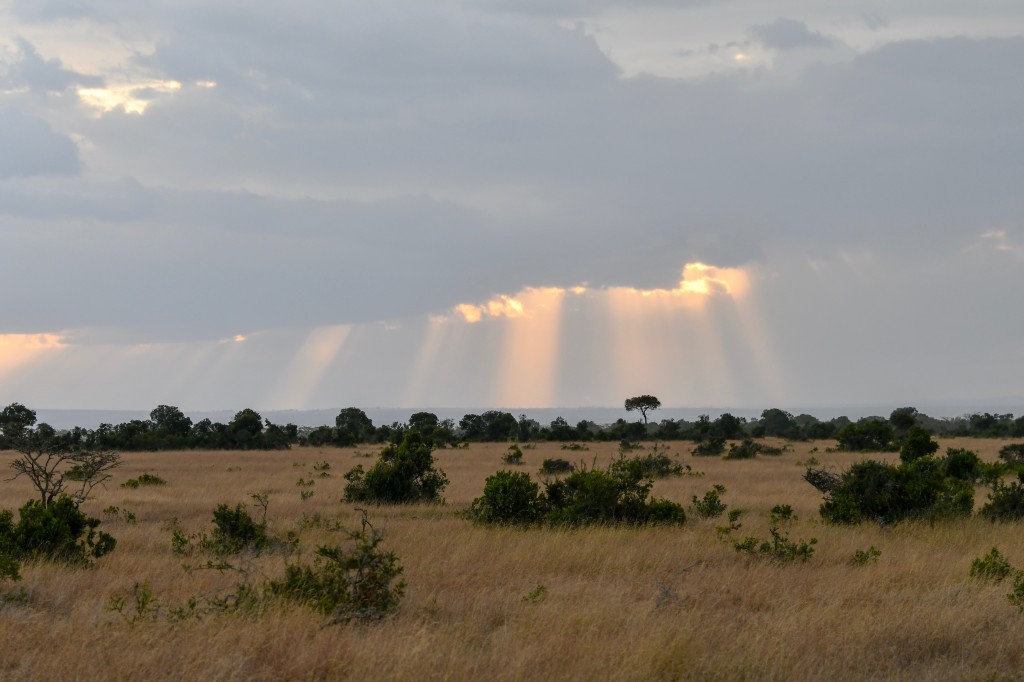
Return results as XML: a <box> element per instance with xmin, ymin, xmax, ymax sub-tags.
<box><xmin>805</xmin><ymin>457</ymin><xmax>974</xmax><ymax>523</ymax></box>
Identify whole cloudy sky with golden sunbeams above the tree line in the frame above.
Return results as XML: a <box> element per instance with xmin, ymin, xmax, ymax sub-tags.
<box><xmin>0</xmin><ymin>0</ymin><xmax>1024</xmax><ymax>410</ymax></box>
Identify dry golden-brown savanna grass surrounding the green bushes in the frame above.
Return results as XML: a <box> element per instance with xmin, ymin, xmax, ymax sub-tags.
<box><xmin>0</xmin><ymin>438</ymin><xmax>1024</xmax><ymax>680</ymax></box>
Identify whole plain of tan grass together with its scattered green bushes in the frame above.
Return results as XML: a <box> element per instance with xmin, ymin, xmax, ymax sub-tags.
<box><xmin>0</xmin><ymin>419</ymin><xmax>1024</xmax><ymax>680</ymax></box>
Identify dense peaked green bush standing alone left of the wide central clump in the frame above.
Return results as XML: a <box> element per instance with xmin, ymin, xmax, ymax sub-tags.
<box><xmin>345</xmin><ymin>430</ymin><xmax>449</xmax><ymax>504</ymax></box>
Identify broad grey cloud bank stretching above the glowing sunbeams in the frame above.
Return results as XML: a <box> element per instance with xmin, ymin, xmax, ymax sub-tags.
<box><xmin>0</xmin><ymin>2</ymin><xmax>1024</xmax><ymax>356</ymax></box>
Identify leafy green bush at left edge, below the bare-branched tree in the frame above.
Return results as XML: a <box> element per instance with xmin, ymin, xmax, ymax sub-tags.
<box><xmin>0</xmin><ymin>496</ymin><xmax>117</xmax><ymax>561</ymax></box>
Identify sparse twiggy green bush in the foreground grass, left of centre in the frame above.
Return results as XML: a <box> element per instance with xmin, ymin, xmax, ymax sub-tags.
<box><xmin>265</xmin><ymin>515</ymin><xmax>406</xmax><ymax>624</ymax></box>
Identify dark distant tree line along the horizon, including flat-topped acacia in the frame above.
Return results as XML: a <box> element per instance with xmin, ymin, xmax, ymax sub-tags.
<box><xmin>0</xmin><ymin>395</ymin><xmax>1024</xmax><ymax>452</ymax></box>
